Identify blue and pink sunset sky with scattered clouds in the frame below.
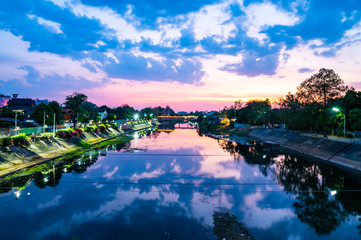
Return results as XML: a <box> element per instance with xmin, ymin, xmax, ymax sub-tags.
<box><xmin>0</xmin><ymin>0</ymin><xmax>361</xmax><ymax>111</ymax></box>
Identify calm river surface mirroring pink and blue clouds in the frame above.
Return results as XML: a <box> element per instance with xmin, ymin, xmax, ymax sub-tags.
<box><xmin>0</xmin><ymin>126</ymin><xmax>361</xmax><ymax>240</ymax></box>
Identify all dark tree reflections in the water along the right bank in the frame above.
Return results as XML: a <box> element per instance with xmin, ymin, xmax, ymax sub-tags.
<box><xmin>218</xmin><ymin>141</ymin><xmax>361</xmax><ymax>235</ymax></box>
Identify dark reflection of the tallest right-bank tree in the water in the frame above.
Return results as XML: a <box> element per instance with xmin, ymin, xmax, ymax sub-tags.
<box><xmin>276</xmin><ymin>155</ymin><xmax>347</xmax><ymax>235</ymax></box>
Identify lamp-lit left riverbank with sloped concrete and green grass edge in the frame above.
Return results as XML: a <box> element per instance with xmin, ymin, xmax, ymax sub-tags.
<box><xmin>0</xmin><ymin>123</ymin><xmax>157</xmax><ymax>177</ymax></box>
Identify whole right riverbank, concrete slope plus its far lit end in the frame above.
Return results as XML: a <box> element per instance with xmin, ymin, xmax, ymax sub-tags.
<box><xmin>206</xmin><ymin>128</ymin><xmax>361</xmax><ymax>174</ymax></box>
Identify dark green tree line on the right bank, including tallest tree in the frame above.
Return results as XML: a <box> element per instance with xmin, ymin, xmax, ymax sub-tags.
<box><xmin>221</xmin><ymin>68</ymin><xmax>361</xmax><ymax>135</ymax></box>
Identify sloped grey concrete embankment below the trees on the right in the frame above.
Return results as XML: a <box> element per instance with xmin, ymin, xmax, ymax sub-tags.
<box><xmin>249</xmin><ymin>128</ymin><xmax>361</xmax><ymax>172</ymax></box>
